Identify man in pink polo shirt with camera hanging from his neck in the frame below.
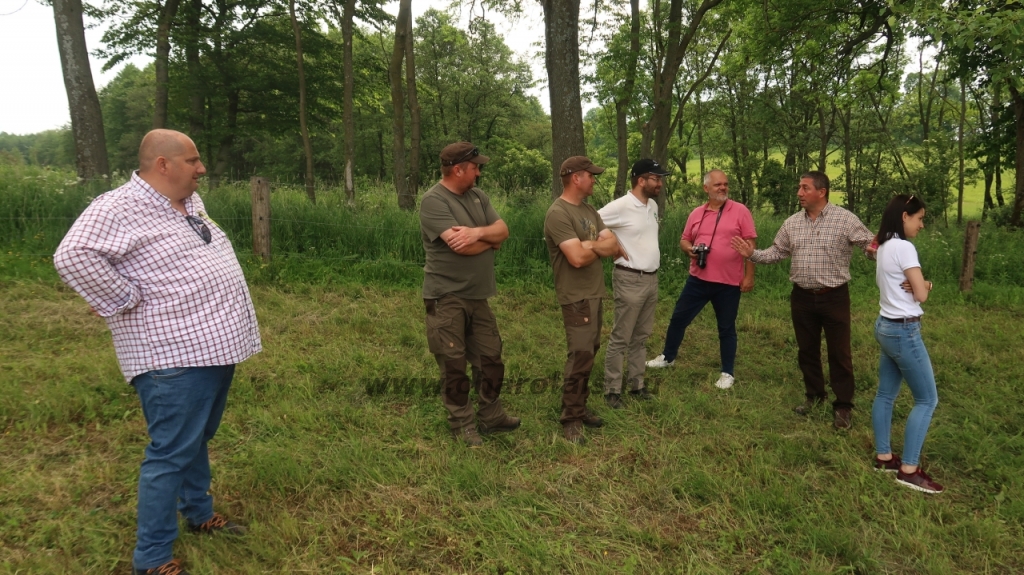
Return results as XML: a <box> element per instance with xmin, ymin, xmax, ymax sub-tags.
<box><xmin>647</xmin><ymin>170</ymin><xmax>758</xmax><ymax>390</ymax></box>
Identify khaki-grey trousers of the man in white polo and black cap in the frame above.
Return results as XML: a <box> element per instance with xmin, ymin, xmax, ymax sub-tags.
<box><xmin>604</xmin><ymin>268</ymin><xmax>657</xmax><ymax>394</ymax></box>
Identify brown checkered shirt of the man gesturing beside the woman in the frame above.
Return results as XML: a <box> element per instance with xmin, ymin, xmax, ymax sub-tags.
<box><xmin>751</xmin><ymin>204</ymin><xmax>874</xmax><ymax>290</ymax></box>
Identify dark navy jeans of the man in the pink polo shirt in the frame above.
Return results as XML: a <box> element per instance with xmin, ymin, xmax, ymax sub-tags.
<box><xmin>662</xmin><ymin>275</ymin><xmax>739</xmax><ymax>375</ymax></box>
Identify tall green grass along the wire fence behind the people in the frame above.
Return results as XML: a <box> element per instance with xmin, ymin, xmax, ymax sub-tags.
<box><xmin>0</xmin><ymin>165</ymin><xmax>1024</xmax><ymax>293</ymax></box>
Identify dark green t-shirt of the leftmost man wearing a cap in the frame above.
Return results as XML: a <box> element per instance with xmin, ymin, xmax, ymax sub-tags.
<box><xmin>420</xmin><ymin>183</ymin><xmax>501</xmax><ymax>300</ymax></box>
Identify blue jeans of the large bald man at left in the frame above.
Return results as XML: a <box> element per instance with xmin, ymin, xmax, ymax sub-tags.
<box><xmin>131</xmin><ymin>365</ymin><xmax>234</xmax><ymax>569</ymax></box>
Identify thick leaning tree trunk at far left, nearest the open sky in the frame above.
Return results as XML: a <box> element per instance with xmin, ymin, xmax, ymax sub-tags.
<box><xmin>53</xmin><ymin>0</ymin><xmax>111</xmax><ymax>181</ymax></box>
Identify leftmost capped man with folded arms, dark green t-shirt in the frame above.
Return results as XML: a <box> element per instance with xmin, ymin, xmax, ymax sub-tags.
<box><xmin>420</xmin><ymin>142</ymin><xmax>519</xmax><ymax>447</ymax></box>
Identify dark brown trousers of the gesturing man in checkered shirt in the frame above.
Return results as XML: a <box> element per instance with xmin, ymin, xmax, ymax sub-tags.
<box><xmin>790</xmin><ymin>284</ymin><xmax>853</xmax><ymax>408</ymax></box>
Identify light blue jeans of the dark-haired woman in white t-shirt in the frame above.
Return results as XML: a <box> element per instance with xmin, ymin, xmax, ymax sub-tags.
<box><xmin>871</xmin><ymin>317</ymin><xmax>939</xmax><ymax>466</ymax></box>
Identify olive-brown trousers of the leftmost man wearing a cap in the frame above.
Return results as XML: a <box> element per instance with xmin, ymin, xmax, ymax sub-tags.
<box><xmin>424</xmin><ymin>294</ymin><xmax>505</xmax><ymax>430</ymax></box>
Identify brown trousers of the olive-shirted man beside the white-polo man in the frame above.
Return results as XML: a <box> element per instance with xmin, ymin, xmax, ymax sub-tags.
<box><xmin>560</xmin><ymin>299</ymin><xmax>601</xmax><ymax>424</ymax></box>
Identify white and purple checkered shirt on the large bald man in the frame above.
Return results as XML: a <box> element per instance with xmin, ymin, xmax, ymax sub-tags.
<box><xmin>53</xmin><ymin>173</ymin><xmax>262</xmax><ymax>382</ymax></box>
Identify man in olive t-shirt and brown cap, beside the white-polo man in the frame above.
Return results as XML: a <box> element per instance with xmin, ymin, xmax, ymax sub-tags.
<box><xmin>544</xmin><ymin>156</ymin><xmax>625</xmax><ymax>444</ymax></box>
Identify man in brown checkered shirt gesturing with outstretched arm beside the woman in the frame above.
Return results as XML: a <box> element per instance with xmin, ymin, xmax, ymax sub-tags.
<box><xmin>731</xmin><ymin>167</ymin><xmax>874</xmax><ymax>429</ymax></box>
